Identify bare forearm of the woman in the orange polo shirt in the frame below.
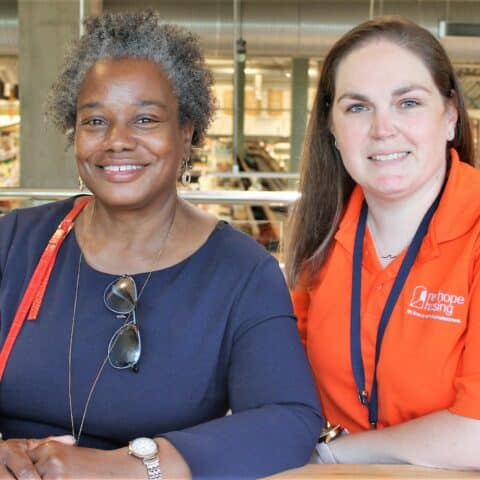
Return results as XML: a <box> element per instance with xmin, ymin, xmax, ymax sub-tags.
<box><xmin>329</xmin><ymin>410</ymin><xmax>480</xmax><ymax>469</ymax></box>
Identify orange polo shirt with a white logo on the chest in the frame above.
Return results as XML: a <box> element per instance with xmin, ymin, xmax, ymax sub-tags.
<box><xmin>293</xmin><ymin>151</ymin><xmax>480</xmax><ymax>432</ymax></box>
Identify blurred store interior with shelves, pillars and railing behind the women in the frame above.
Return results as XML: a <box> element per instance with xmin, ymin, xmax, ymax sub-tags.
<box><xmin>0</xmin><ymin>0</ymin><xmax>480</xmax><ymax>256</ymax></box>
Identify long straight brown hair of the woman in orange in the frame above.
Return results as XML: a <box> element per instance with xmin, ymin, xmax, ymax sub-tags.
<box><xmin>286</xmin><ymin>16</ymin><xmax>474</xmax><ymax>287</ymax></box>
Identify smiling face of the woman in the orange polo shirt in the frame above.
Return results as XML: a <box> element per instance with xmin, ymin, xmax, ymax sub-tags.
<box><xmin>330</xmin><ymin>40</ymin><xmax>457</xmax><ymax>204</ymax></box>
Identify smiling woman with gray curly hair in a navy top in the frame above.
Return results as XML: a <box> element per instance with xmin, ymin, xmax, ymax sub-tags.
<box><xmin>0</xmin><ymin>7</ymin><xmax>322</xmax><ymax>480</ymax></box>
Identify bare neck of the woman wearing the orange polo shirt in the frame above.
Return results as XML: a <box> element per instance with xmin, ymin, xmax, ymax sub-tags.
<box><xmin>365</xmin><ymin>172</ymin><xmax>443</xmax><ymax>266</ymax></box>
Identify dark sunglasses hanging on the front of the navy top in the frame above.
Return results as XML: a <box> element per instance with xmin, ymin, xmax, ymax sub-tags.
<box><xmin>103</xmin><ymin>275</ymin><xmax>142</xmax><ymax>372</ymax></box>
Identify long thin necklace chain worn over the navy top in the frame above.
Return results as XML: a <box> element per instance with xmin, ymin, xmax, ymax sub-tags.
<box><xmin>68</xmin><ymin>199</ymin><xmax>178</xmax><ymax>445</ymax></box>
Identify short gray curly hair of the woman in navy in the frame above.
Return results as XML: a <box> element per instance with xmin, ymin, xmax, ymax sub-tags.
<box><xmin>46</xmin><ymin>10</ymin><xmax>214</xmax><ymax>146</ymax></box>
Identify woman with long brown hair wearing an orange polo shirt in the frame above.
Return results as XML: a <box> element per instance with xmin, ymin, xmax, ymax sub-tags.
<box><xmin>288</xmin><ymin>17</ymin><xmax>480</xmax><ymax>469</ymax></box>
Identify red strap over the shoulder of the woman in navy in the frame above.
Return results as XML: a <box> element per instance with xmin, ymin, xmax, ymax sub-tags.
<box><xmin>0</xmin><ymin>197</ymin><xmax>91</xmax><ymax>381</ymax></box>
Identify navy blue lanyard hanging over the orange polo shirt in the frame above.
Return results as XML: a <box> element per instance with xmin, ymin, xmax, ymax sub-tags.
<box><xmin>350</xmin><ymin>192</ymin><xmax>442</xmax><ymax>428</ymax></box>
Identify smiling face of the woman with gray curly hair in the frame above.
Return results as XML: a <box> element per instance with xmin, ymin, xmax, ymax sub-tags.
<box><xmin>74</xmin><ymin>58</ymin><xmax>192</xmax><ymax>207</ymax></box>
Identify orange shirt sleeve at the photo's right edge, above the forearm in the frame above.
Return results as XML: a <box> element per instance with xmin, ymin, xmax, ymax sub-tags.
<box><xmin>449</xmin><ymin>241</ymin><xmax>480</xmax><ymax>419</ymax></box>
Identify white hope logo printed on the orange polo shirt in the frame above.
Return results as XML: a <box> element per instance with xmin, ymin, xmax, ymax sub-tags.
<box><xmin>407</xmin><ymin>285</ymin><xmax>465</xmax><ymax>323</ymax></box>
